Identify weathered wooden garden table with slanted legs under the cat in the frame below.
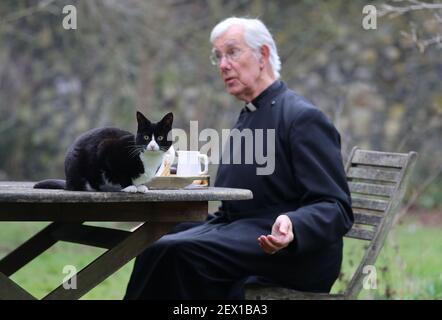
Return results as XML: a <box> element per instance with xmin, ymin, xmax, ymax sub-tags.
<box><xmin>0</xmin><ymin>181</ymin><xmax>253</xmax><ymax>299</ymax></box>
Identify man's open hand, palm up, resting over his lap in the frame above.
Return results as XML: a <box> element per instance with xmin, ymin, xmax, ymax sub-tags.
<box><xmin>258</xmin><ymin>214</ymin><xmax>294</xmax><ymax>254</ymax></box>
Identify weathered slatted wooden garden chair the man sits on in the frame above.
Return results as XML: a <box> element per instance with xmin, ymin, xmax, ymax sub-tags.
<box><xmin>246</xmin><ymin>147</ymin><xmax>417</xmax><ymax>300</ymax></box>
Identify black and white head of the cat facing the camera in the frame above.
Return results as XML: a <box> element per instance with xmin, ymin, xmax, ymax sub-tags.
<box><xmin>136</xmin><ymin>111</ymin><xmax>173</xmax><ymax>152</ymax></box>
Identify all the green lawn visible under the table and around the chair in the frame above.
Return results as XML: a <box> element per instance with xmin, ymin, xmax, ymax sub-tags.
<box><xmin>0</xmin><ymin>221</ymin><xmax>442</xmax><ymax>300</ymax></box>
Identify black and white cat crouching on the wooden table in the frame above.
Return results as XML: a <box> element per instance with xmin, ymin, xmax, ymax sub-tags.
<box><xmin>34</xmin><ymin>112</ymin><xmax>175</xmax><ymax>193</ymax></box>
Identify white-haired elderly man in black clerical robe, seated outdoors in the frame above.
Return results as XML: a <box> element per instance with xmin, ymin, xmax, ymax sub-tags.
<box><xmin>125</xmin><ymin>18</ymin><xmax>353</xmax><ymax>299</ymax></box>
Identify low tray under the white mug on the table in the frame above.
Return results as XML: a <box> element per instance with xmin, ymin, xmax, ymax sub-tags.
<box><xmin>145</xmin><ymin>175</ymin><xmax>209</xmax><ymax>190</ymax></box>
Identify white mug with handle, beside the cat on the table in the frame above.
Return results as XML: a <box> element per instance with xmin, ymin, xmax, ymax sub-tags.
<box><xmin>176</xmin><ymin>151</ymin><xmax>209</xmax><ymax>177</ymax></box>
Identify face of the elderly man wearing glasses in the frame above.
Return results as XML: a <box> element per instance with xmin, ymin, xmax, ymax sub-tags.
<box><xmin>213</xmin><ymin>26</ymin><xmax>261</xmax><ymax>101</ymax></box>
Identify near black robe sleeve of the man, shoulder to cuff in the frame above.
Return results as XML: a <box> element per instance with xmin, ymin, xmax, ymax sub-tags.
<box><xmin>286</xmin><ymin>108</ymin><xmax>353</xmax><ymax>253</ymax></box>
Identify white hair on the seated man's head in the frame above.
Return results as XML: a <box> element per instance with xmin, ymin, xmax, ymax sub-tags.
<box><xmin>210</xmin><ymin>17</ymin><xmax>281</xmax><ymax>79</ymax></box>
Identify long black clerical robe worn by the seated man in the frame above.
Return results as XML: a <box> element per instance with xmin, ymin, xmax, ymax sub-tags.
<box><xmin>125</xmin><ymin>81</ymin><xmax>353</xmax><ymax>299</ymax></box>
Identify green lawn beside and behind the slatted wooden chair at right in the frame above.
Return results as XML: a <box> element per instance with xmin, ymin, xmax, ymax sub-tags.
<box><xmin>332</xmin><ymin>221</ymin><xmax>442</xmax><ymax>299</ymax></box>
